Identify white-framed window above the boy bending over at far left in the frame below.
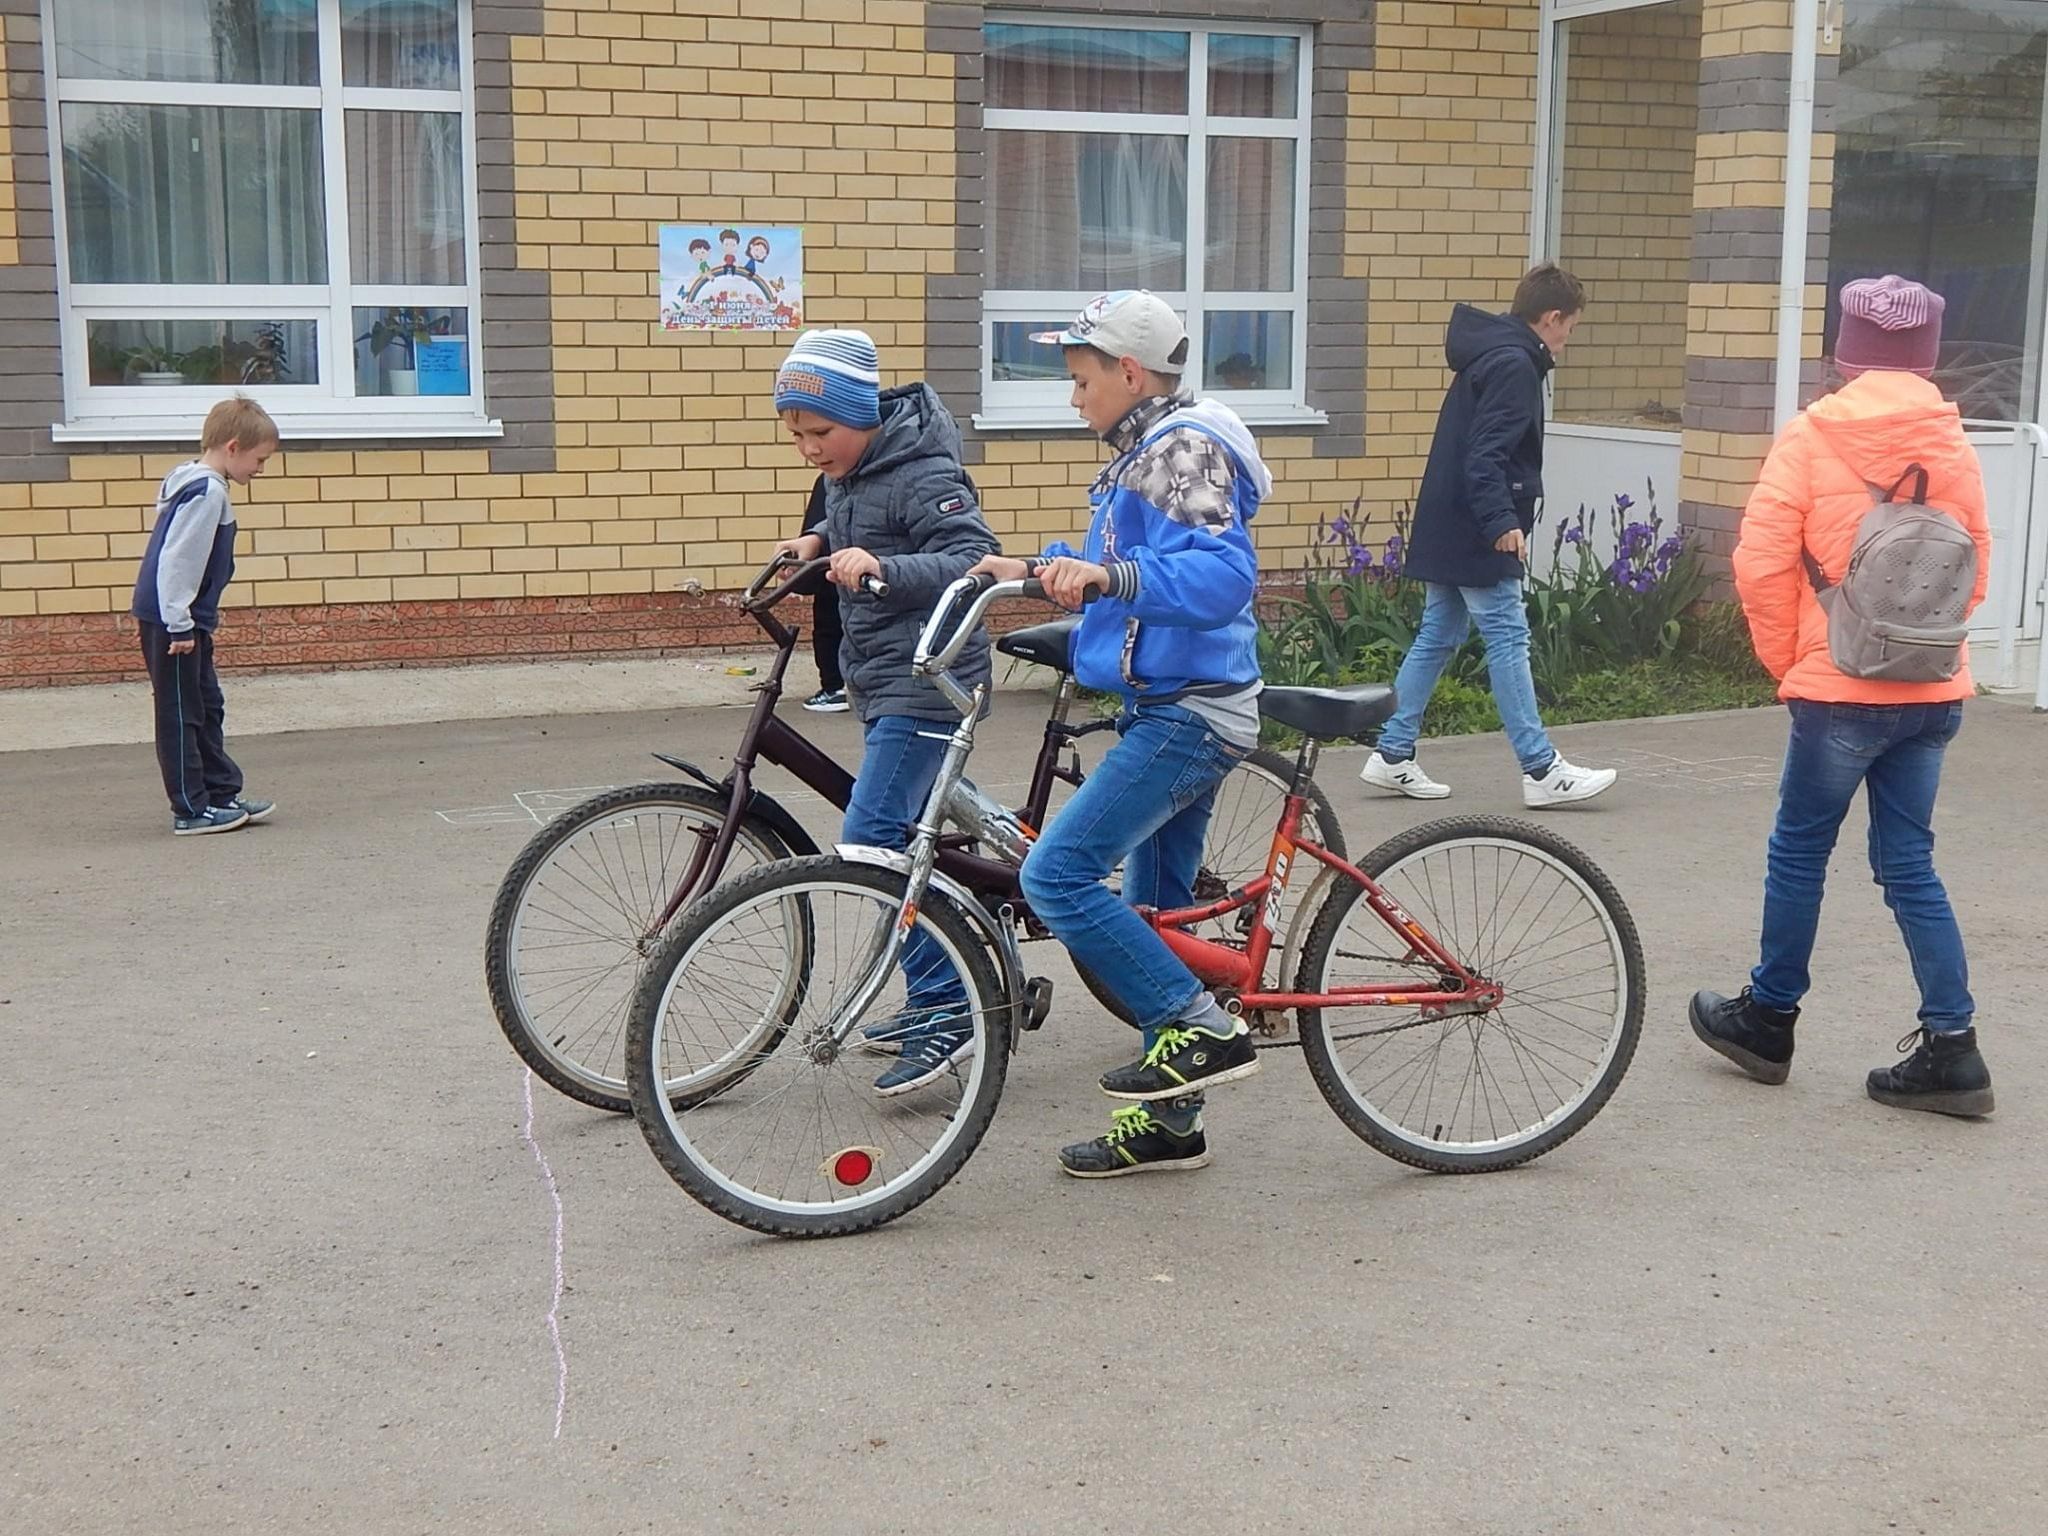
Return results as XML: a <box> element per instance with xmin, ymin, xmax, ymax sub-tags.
<box><xmin>43</xmin><ymin>0</ymin><xmax>483</xmax><ymax>438</ymax></box>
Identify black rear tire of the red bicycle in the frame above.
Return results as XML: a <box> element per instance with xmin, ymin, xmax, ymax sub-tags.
<box><xmin>1294</xmin><ymin>815</ymin><xmax>1645</xmax><ymax>1174</ymax></box>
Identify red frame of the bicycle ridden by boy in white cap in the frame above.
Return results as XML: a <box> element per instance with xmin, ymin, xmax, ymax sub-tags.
<box><xmin>1141</xmin><ymin>761</ymin><xmax>1503</xmax><ymax>1012</ymax></box>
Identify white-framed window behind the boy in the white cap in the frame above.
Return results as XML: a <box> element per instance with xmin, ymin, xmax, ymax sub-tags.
<box><xmin>979</xmin><ymin>18</ymin><xmax>1311</xmax><ymax>426</ymax></box>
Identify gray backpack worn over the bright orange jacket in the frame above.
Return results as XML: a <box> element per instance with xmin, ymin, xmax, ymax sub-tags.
<box><xmin>1800</xmin><ymin>465</ymin><xmax>1976</xmax><ymax>682</ymax></box>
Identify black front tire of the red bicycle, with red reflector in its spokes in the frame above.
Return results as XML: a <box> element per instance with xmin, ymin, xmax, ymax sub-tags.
<box><xmin>627</xmin><ymin>854</ymin><xmax>1010</xmax><ymax>1237</ymax></box>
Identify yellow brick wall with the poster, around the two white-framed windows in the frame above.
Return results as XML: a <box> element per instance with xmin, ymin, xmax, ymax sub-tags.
<box><xmin>0</xmin><ymin>0</ymin><xmax>1548</xmax><ymax>616</ymax></box>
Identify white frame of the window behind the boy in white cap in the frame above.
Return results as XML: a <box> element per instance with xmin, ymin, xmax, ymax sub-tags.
<box><xmin>975</xmin><ymin>12</ymin><xmax>1327</xmax><ymax>432</ymax></box>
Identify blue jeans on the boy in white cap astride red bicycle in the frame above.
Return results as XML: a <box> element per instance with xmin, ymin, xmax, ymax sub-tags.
<box><xmin>1022</xmin><ymin>705</ymin><xmax>1245</xmax><ymax>1047</ymax></box>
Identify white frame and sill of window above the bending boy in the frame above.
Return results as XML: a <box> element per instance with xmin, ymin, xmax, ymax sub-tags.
<box><xmin>43</xmin><ymin>0</ymin><xmax>504</xmax><ymax>442</ymax></box>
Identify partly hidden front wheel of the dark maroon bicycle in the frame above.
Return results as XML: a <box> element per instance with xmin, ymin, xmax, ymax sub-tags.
<box><xmin>483</xmin><ymin>782</ymin><xmax>788</xmax><ymax>1114</ymax></box>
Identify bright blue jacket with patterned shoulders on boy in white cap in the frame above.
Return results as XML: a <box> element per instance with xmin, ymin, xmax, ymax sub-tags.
<box><xmin>1044</xmin><ymin>395</ymin><xmax>1274</xmax><ymax>702</ymax></box>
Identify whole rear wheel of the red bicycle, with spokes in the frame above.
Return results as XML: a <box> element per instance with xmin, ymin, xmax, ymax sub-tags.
<box><xmin>1294</xmin><ymin>815</ymin><xmax>1642</xmax><ymax>1174</ymax></box>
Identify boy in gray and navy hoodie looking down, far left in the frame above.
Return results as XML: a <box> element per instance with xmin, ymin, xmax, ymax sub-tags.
<box><xmin>129</xmin><ymin>395</ymin><xmax>279</xmax><ymax>838</ymax></box>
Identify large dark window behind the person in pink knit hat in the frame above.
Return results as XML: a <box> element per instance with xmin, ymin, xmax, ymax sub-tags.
<box><xmin>1827</xmin><ymin>0</ymin><xmax>2048</xmax><ymax>422</ymax></box>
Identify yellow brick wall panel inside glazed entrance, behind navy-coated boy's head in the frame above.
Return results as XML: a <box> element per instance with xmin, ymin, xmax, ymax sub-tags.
<box><xmin>1552</xmin><ymin>0</ymin><xmax>1700</xmax><ymax>428</ymax></box>
